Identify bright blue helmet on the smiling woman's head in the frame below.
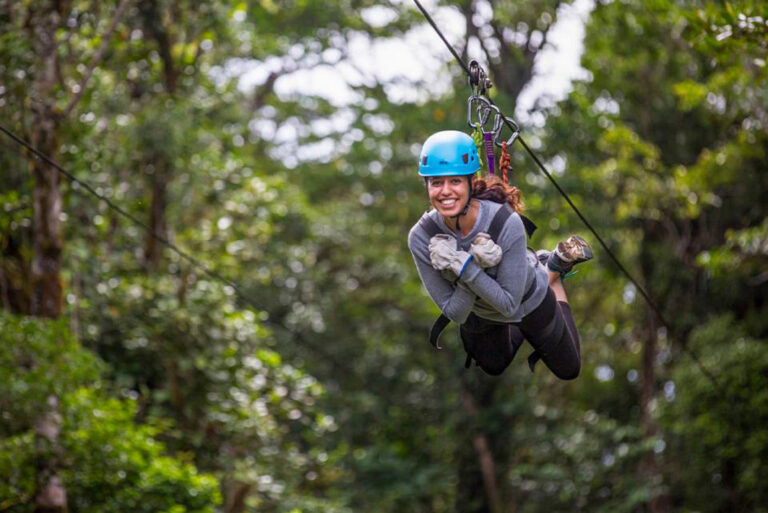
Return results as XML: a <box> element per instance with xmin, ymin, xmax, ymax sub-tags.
<box><xmin>419</xmin><ymin>130</ymin><xmax>480</xmax><ymax>177</ymax></box>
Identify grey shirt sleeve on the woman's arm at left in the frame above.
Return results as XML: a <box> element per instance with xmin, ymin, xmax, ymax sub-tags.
<box><xmin>408</xmin><ymin>224</ymin><xmax>474</xmax><ymax>324</ymax></box>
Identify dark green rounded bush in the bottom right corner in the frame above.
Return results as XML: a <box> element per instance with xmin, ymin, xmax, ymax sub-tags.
<box><xmin>662</xmin><ymin>315</ymin><xmax>768</xmax><ymax>512</ymax></box>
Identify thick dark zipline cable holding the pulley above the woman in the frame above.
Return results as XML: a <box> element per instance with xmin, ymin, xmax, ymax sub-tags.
<box><xmin>413</xmin><ymin>0</ymin><xmax>719</xmax><ymax>386</ymax></box>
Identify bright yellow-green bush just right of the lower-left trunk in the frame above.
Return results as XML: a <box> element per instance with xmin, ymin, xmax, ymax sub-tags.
<box><xmin>62</xmin><ymin>390</ymin><xmax>221</xmax><ymax>513</ymax></box>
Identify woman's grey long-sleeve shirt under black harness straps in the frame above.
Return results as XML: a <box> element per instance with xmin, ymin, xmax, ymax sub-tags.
<box><xmin>408</xmin><ymin>200</ymin><xmax>548</xmax><ymax>324</ymax></box>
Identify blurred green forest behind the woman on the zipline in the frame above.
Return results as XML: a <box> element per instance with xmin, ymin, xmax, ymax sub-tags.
<box><xmin>0</xmin><ymin>0</ymin><xmax>768</xmax><ymax>513</ymax></box>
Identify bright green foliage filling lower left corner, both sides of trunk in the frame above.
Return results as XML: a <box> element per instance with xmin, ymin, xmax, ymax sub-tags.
<box><xmin>0</xmin><ymin>313</ymin><xmax>221</xmax><ymax>512</ymax></box>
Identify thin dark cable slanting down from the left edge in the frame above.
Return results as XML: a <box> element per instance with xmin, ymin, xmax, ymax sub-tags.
<box><xmin>0</xmin><ymin>124</ymin><xmax>356</xmax><ymax>380</ymax></box>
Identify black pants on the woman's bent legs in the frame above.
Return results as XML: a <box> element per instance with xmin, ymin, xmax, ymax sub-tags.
<box><xmin>460</xmin><ymin>288</ymin><xmax>581</xmax><ymax>379</ymax></box>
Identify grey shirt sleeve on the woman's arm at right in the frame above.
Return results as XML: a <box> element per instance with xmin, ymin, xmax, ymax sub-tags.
<box><xmin>461</xmin><ymin>211</ymin><xmax>535</xmax><ymax>317</ymax></box>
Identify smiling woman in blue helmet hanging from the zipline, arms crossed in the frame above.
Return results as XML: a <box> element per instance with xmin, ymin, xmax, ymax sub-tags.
<box><xmin>408</xmin><ymin>131</ymin><xmax>592</xmax><ymax>379</ymax></box>
